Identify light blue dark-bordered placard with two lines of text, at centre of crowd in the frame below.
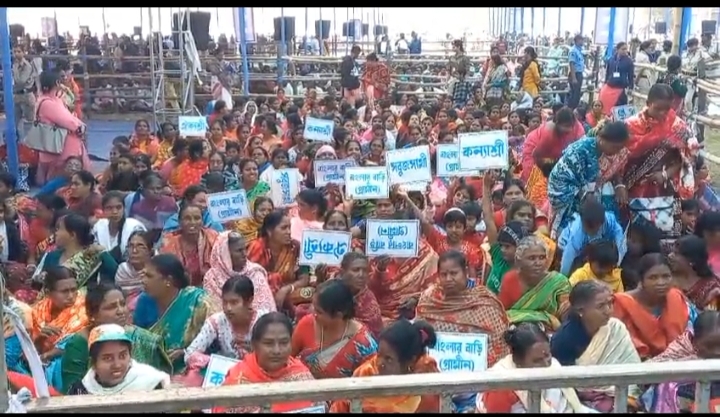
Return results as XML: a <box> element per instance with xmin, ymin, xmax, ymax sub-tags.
<box><xmin>365</xmin><ymin>219</ymin><xmax>420</xmax><ymax>258</ymax></box>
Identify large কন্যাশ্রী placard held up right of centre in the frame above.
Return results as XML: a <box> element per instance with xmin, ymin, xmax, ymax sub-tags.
<box><xmin>458</xmin><ymin>130</ymin><xmax>510</xmax><ymax>171</ymax></box>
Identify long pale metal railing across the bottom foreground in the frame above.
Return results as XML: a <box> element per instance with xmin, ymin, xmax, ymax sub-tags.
<box><xmin>28</xmin><ymin>360</ymin><xmax>720</xmax><ymax>413</ymax></box>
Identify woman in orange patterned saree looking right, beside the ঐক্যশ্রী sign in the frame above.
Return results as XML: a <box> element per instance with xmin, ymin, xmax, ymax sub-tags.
<box><xmin>247</xmin><ymin>210</ymin><xmax>315</xmax><ymax>313</ymax></box>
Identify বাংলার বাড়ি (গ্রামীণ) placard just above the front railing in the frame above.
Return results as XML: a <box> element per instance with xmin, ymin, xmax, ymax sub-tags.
<box><xmin>429</xmin><ymin>332</ymin><xmax>488</xmax><ymax>372</ymax></box>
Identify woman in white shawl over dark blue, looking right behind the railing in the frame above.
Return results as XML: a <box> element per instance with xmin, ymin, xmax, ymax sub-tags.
<box><xmin>550</xmin><ymin>281</ymin><xmax>640</xmax><ymax>413</ymax></box>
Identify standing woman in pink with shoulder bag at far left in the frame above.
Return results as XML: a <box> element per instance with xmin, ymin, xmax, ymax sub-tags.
<box><xmin>28</xmin><ymin>71</ymin><xmax>90</xmax><ymax>185</ymax></box>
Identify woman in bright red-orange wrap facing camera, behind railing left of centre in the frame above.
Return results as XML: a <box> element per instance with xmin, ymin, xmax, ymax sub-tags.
<box><xmin>213</xmin><ymin>312</ymin><xmax>325</xmax><ymax>414</ymax></box>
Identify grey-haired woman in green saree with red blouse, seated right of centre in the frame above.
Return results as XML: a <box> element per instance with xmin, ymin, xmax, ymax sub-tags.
<box><xmin>498</xmin><ymin>236</ymin><xmax>570</xmax><ymax>332</ymax></box>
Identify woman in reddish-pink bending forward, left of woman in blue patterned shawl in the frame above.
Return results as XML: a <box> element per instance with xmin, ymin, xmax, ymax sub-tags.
<box><xmin>521</xmin><ymin>107</ymin><xmax>585</xmax><ymax>211</ymax></box>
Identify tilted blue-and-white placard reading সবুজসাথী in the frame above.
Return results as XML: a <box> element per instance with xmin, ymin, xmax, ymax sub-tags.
<box><xmin>385</xmin><ymin>145</ymin><xmax>432</xmax><ymax>185</ymax></box>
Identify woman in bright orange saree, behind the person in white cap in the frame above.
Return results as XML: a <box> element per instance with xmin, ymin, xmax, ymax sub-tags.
<box><xmin>29</xmin><ymin>267</ymin><xmax>88</xmax><ymax>354</ymax></box>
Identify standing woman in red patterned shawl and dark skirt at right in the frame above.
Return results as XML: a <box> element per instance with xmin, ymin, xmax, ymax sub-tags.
<box><xmin>623</xmin><ymin>84</ymin><xmax>698</xmax><ymax>239</ymax></box>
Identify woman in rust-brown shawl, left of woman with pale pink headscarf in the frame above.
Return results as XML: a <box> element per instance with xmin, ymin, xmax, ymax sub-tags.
<box><xmin>159</xmin><ymin>204</ymin><xmax>218</xmax><ymax>288</ymax></box>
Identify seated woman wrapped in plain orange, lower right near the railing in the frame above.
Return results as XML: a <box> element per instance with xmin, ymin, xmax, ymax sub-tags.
<box><xmin>613</xmin><ymin>253</ymin><xmax>697</xmax><ymax>360</ymax></box>
